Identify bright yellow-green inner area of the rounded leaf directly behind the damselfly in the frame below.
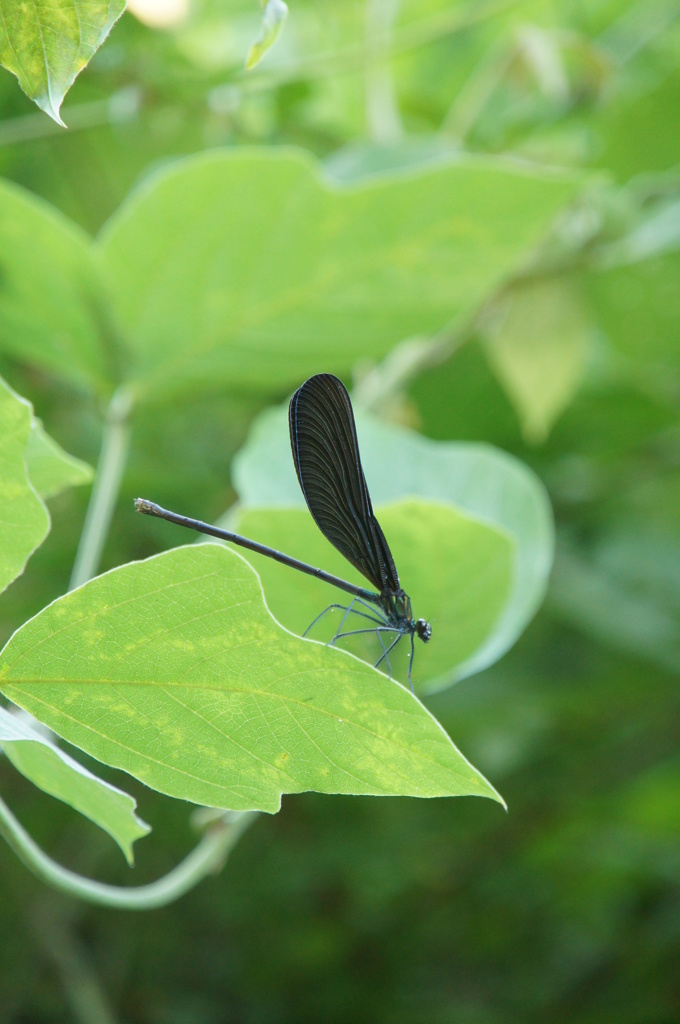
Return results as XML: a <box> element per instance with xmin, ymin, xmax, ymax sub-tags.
<box><xmin>231</xmin><ymin>499</ymin><xmax>515</xmax><ymax>692</ymax></box>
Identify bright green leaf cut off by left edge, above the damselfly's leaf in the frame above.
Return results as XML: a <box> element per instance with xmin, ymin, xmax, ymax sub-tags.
<box><xmin>0</xmin><ymin>379</ymin><xmax>49</xmax><ymax>592</ymax></box>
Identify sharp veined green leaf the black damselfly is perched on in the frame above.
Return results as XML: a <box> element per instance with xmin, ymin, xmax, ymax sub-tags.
<box><xmin>0</xmin><ymin>544</ymin><xmax>500</xmax><ymax>811</ymax></box>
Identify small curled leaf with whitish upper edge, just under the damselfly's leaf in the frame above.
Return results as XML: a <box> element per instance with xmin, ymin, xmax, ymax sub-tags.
<box><xmin>0</xmin><ymin>708</ymin><xmax>151</xmax><ymax>864</ymax></box>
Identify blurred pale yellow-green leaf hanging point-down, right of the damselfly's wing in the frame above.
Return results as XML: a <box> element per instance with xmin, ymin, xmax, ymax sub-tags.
<box><xmin>483</xmin><ymin>274</ymin><xmax>590</xmax><ymax>443</ymax></box>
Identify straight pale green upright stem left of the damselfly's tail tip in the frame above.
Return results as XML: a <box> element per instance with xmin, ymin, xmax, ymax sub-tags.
<box><xmin>69</xmin><ymin>388</ymin><xmax>132</xmax><ymax>590</ymax></box>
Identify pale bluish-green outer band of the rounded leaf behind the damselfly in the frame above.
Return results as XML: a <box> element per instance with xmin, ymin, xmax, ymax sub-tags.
<box><xmin>233</xmin><ymin>409</ymin><xmax>553</xmax><ymax>689</ymax></box>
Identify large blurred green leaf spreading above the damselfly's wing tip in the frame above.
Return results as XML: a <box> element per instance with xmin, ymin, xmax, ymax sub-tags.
<box><xmin>99</xmin><ymin>150</ymin><xmax>577</xmax><ymax>394</ymax></box>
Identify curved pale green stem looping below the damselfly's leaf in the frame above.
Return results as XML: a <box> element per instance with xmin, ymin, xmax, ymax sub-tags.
<box><xmin>0</xmin><ymin>798</ymin><xmax>257</xmax><ymax>910</ymax></box>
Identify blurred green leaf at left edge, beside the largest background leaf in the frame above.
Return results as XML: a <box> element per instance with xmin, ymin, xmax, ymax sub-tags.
<box><xmin>0</xmin><ymin>181</ymin><xmax>113</xmax><ymax>387</ymax></box>
